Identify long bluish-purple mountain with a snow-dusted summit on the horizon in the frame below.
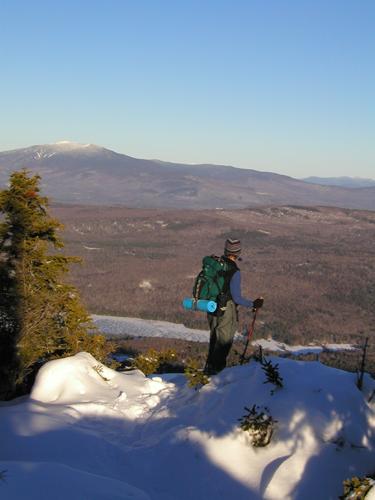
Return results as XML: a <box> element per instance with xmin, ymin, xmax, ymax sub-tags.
<box><xmin>0</xmin><ymin>141</ymin><xmax>375</xmax><ymax>210</ymax></box>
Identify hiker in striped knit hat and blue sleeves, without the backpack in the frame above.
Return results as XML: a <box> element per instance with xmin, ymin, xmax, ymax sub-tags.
<box><xmin>205</xmin><ymin>239</ymin><xmax>263</xmax><ymax>375</ymax></box>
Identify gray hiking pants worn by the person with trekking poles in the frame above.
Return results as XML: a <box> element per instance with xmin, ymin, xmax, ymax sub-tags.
<box><xmin>206</xmin><ymin>300</ymin><xmax>238</xmax><ymax>373</ymax></box>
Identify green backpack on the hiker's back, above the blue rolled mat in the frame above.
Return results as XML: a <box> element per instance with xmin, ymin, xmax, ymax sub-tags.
<box><xmin>193</xmin><ymin>255</ymin><xmax>229</xmax><ymax>305</ymax></box>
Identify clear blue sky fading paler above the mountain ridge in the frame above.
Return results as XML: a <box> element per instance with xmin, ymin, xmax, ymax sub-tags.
<box><xmin>0</xmin><ymin>0</ymin><xmax>375</xmax><ymax>178</ymax></box>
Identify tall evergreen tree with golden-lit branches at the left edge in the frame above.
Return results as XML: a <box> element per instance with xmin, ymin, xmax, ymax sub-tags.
<box><xmin>0</xmin><ymin>170</ymin><xmax>106</xmax><ymax>399</ymax></box>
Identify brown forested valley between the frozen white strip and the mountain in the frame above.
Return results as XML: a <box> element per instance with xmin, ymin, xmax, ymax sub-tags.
<box><xmin>53</xmin><ymin>206</ymin><xmax>375</xmax><ymax>344</ymax></box>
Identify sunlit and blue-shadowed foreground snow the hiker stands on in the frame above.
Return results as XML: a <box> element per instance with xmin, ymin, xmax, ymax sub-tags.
<box><xmin>0</xmin><ymin>353</ymin><xmax>375</xmax><ymax>500</ymax></box>
